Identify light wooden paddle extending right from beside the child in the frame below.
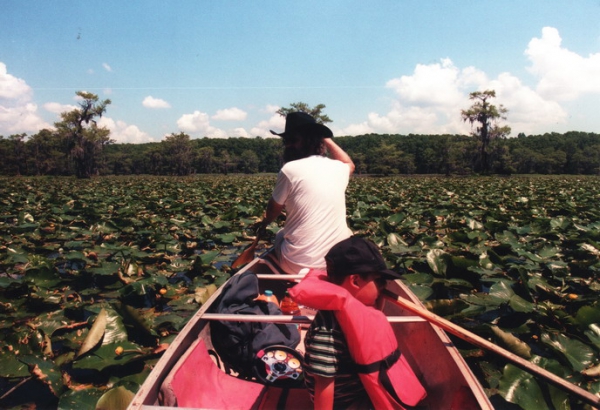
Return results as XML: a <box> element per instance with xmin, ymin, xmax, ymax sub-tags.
<box><xmin>384</xmin><ymin>290</ymin><xmax>600</xmax><ymax>408</ymax></box>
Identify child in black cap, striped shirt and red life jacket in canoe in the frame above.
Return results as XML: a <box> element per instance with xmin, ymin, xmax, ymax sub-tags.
<box><xmin>290</xmin><ymin>237</ymin><xmax>425</xmax><ymax>409</ymax></box>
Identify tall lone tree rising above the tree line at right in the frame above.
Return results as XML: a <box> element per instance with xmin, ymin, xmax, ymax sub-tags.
<box><xmin>461</xmin><ymin>90</ymin><xmax>510</xmax><ymax>174</ymax></box>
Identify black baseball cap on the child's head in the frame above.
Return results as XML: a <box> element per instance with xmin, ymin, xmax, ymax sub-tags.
<box><xmin>325</xmin><ymin>236</ymin><xmax>402</xmax><ymax>279</ymax></box>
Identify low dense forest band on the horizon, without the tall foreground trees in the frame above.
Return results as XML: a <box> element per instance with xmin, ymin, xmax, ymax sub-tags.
<box><xmin>0</xmin><ymin>130</ymin><xmax>600</xmax><ymax>176</ymax></box>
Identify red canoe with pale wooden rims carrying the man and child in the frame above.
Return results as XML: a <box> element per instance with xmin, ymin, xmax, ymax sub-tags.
<box><xmin>129</xmin><ymin>251</ymin><xmax>493</xmax><ymax>410</ymax></box>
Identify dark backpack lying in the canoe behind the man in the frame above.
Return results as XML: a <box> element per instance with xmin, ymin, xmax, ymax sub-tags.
<box><xmin>210</xmin><ymin>271</ymin><xmax>300</xmax><ymax>379</ymax></box>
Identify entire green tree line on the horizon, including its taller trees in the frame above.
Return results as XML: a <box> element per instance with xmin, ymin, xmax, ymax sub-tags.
<box><xmin>0</xmin><ymin>90</ymin><xmax>600</xmax><ymax>178</ymax></box>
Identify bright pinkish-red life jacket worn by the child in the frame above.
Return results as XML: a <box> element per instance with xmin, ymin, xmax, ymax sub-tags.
<box><xmin>290</xmin><ymin>270</ymin><xmax>427</xmax><ymax>409</ymax></box>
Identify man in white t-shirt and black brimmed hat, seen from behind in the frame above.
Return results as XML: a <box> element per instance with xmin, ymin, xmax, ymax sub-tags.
<box><xmin>259</xmin><ymin>112</ymin><xmax>354</xmax><ymax>274</ymax></box>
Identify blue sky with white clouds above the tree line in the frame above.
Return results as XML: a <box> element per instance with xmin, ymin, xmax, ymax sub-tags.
<box><xmin>0</xmin><ymin>0</ymin><xmax>600</xmax><ymax>143</ymax></box>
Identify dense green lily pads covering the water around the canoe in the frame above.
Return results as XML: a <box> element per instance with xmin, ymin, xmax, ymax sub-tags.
<box><xmin>0</xmin><ymin>175</ymin><xmax>600</xmax><ymax>409</ymax></box>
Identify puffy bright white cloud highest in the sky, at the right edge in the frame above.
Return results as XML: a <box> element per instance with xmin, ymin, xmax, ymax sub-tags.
<box><xmin>525</xmin><ymin>27</ymin><xmax>600</xmax><ymax>101</ymax></box>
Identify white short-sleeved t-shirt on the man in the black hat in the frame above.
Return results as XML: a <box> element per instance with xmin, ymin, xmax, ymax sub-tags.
<box><xmin>273</xmin><ymin>155</ymin><xmax>352</xmax><ymax>273</ymax></box>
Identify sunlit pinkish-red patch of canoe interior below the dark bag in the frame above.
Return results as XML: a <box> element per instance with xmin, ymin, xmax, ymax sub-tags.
<box><xmin>159</xmin><ymin>339</ymin><xmax>265</xmax><ymax>409</ymax></box>
